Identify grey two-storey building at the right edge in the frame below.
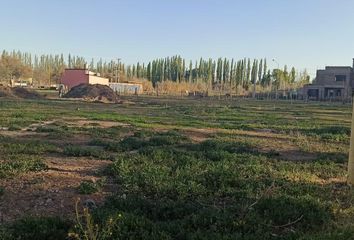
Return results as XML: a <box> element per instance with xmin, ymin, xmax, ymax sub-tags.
<box><xmin>303</xmin><ymin>59</ymin><xmax>354</xmax><ymax>100</ymax></box>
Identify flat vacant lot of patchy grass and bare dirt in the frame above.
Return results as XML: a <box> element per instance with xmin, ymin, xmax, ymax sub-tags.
<box><xmin>0</xmin><ymin>97</ymin><xmax>354</xmax><ymax>239</ymax></box>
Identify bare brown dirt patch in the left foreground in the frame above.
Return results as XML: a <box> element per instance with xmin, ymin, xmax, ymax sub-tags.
<box><xmin>0</xmin><ymin>157</ymin><xmax>117</xmax><ymax>223</ymax></box>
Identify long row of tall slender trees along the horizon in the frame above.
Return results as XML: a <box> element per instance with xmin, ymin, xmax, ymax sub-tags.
<box><xmin>0</xmin><ymin>51</ymin><xmax>309</xmax><ymax>93</ymax></box>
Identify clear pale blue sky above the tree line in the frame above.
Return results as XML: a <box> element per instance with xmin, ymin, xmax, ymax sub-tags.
<box><xmin>0</xmin><ymin>0</ymin><xmax>354</xmax><ymax>76</ymax></box>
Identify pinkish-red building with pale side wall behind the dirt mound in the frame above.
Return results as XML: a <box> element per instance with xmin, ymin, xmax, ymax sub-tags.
<box><xmin>60</xmin><ymin>69</ymin><xmax>109</xmax><ymax>89</ymax></box>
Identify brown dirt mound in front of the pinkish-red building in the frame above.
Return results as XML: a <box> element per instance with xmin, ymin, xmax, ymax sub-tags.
<box><xmin>64</xmin><ymin>84</ymin><xmax>120</xmax><ymax>103</ymax></box>
